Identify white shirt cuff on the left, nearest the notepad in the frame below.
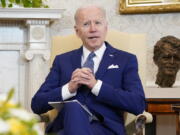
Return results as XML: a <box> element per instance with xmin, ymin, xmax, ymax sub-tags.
<box><xmin>61</xmin><ymin>83</ymin><xmax>76</xmax><ymax>100</ymax></box>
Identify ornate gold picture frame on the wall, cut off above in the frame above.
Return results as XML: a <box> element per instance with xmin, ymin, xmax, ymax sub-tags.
<box><xmin>119</xmin><ymin>0</ymin><xmax>180</xmax><ymax>14</ymax></box>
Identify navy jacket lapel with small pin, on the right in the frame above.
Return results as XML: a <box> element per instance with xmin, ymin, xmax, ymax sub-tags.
<box><xmin>96</xmin><ymin>42</ymin><xmax>115</xmax><ymax>79</ymax></box>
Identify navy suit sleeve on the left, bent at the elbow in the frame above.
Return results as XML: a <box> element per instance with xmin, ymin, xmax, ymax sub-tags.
<box><xmin>31</xmin><ymin>58</ymin><xmax>62</xmax><ymax>114</ymax></box>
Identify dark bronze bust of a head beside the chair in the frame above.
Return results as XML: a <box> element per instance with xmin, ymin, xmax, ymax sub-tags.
<box><xmin>153</xmin><ymin>36</ymin><xmax>180</xmax><ymax>88</ymax></box>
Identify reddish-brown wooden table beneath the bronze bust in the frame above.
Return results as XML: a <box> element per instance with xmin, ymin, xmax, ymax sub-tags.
<box><xmin>147</xmin><ymin>98</ymin><xmax>180</xmax><ymax>135</ymax></box>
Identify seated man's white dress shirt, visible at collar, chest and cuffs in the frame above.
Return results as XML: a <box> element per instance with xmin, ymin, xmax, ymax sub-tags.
<box><xmin>62</xmin><ymin>43</ymin><xmax>106</xmax><ymax>100</ymax></box>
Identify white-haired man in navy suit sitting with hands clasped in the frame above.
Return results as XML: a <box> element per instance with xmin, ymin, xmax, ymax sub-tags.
<box><xmin>31</xmin><ymin>6</ymin><xmax>145</xmax><ymax>135</ymax></box>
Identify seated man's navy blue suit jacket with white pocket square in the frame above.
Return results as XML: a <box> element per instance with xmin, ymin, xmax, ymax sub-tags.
<box><xmin>31</xmin><ymin>42</ymin><xmax>145</xmax><ymax>135</ymax></box>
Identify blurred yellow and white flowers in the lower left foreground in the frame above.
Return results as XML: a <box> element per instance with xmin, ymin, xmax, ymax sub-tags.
<box><xmin>0</xmin><ymin>89</ymin><xmax>43</xmax><ymax>135</ymax></box>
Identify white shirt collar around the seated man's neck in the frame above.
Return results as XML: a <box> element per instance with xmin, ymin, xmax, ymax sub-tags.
<box><xmin>83</xmin><ymin>42</ymin><xmax>106</xmax><ymax>59</ymax></box>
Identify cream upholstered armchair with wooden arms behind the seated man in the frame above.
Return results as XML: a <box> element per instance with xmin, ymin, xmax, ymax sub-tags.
<box><xmin>41</xmin><ymin>30</ymin><xmax>152</xmax><ymax>135</ymax></box>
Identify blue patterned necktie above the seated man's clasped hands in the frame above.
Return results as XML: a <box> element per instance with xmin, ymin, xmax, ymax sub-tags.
<box><xmin>83</xmin><ymin>52</ymin><xmax>96</xmax><ymax>73</ymax></box>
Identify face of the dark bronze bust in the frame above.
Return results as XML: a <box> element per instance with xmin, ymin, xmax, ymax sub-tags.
<box><xmin>157</xmin><ymin>43</ymin><xmax>180</xmax><ymax>75</ymax></box>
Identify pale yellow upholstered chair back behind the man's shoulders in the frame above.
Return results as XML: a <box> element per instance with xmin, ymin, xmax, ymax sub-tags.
<box><xmin>51</xmin><ymin>30</ymin><xmax>146</xmax><ymax>87</ymax></box>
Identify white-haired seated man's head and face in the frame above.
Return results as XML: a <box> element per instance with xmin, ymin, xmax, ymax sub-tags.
<box><xmin>75</xmin><ymin>7</ymin><xmax>107</xmax><ymax>51</ymax></box>
